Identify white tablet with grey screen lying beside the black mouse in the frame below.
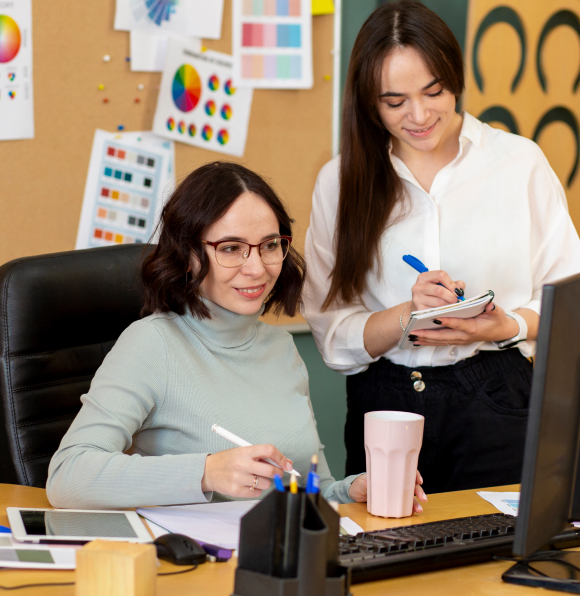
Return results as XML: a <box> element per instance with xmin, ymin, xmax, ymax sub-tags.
<box><xmin>6</xmin><ymin>507</ymin><xmax>153</xmax><ymax>544</ymax></box>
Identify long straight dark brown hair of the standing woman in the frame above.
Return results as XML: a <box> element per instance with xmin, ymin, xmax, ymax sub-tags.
<box><xmin>322</xmin><ymin>0</ymin><xmax>464</xmax><ymax>310</ymax></box>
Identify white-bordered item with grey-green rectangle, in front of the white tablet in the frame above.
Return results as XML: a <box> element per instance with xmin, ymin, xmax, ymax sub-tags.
<box><xmin>0</xmin><ymin>534</ymin><xmax>80</xmax><ymax>569</ymax></box>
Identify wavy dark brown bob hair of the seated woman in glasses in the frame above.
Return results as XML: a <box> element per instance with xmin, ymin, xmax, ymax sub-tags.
<box><xmin>141</xmin><ymin>162</ymin><xmax>305</xmax><ymax>319</ymax></box>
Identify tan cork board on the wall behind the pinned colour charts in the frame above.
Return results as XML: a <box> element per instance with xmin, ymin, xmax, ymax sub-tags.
<box><xmin>0</xmin><ymin>0</ymin><xmax>334</xmax><ymax>324</ymax></box>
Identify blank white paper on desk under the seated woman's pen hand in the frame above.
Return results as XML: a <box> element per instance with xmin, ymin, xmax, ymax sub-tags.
<box><xmin>137</xmin><ymin>501</ymin><xmax>259</xmax><ymax>550</ymax></box>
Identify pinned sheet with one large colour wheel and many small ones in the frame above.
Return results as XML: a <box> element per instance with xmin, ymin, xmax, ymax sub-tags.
<box><xmin>153</xmin><ymin>39</ymin><xmax>253</xmax><ymax>157</ymax></box>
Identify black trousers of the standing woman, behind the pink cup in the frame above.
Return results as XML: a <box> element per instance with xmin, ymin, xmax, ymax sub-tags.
<box><xmin>344</xmin><ymin>348</ymin><xmax>532</xmax><ymax>493</ymax></box>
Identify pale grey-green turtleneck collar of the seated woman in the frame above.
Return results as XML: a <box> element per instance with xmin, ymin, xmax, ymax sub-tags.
<box><xmin>182</xmin><ymin>298</ymin><xmax>264</xmax><ymax>349</ymax></box>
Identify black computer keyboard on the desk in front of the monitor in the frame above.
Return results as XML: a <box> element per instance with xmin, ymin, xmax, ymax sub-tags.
<box><xmin>339</xmin><ymin>513</ymin><xmax>580</xmax><ymax>584</ymax></box>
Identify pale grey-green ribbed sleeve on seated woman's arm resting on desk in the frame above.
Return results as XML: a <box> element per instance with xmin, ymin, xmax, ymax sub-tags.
<box><xmin>46</xmin><ymin>319</ymin><xmax>212</xmax><ymax>509</ymax></box>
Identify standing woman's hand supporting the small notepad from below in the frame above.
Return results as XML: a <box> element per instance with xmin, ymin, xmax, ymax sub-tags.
<box><xmin>413</xmin><ymin>304</ymin><xmax>519</xmax><ymax>346</ymax></box>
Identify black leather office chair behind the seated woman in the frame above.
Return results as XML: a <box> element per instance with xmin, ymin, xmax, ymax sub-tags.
<box><xmin>0</xmin><ymin>244</ymin><xmax>153</xmax><ymax>487</ymax></box>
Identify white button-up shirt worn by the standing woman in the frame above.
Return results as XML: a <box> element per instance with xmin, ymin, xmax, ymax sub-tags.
<box><xmin>304</xmin><ymin>112</ymin><xmax>580</xmax><ymax>374</ymax></box>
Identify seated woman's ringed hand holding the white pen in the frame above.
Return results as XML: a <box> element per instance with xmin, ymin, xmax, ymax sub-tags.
<box><xmin>201</xmin><ymin>445</ymin><xmax>292</xmax><ymax>499</ymax></box>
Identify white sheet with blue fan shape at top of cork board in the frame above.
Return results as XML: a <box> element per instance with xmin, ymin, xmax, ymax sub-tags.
<box><xmin>114</xmin><ymin>0</ymin><xmax>224</xmax><ymax>39</ymax></box>
